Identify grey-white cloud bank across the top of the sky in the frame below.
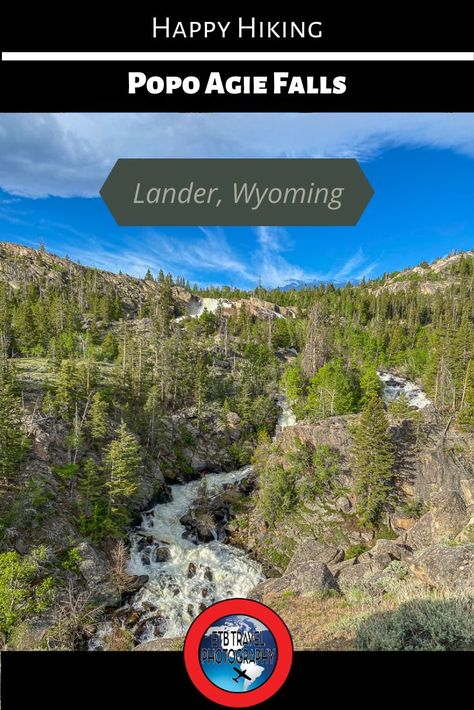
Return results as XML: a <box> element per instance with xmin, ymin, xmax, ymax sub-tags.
<box><xmin>0</xmin><ymin>113</ymin><xmax>474</xmax><ymax>197</ymax></box>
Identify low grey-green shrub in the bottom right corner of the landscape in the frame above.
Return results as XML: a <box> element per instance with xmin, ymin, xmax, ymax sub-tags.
<box><xmin>356</xmin><ymin>599</ymin><xmax>474</xmax><ymax>651</ymax></box>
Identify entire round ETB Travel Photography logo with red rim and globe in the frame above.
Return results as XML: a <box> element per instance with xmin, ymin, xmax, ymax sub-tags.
<box><xmin>184</xmin><ymin>599</ymin><xmax>293</xmax><ymax>708</ymax></box>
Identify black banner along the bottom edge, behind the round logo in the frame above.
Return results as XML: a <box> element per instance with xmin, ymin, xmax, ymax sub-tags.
<box><xmin>2</xmin><ymin>651</ymin><xmax>466</xmax><ymax>710</ymax></box>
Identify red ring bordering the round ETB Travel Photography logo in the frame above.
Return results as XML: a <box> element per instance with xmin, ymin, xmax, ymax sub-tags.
<box><xmin>184</xmin><ymin>599</ymin><xmax>293</xmax><ymax>708</ymax></box>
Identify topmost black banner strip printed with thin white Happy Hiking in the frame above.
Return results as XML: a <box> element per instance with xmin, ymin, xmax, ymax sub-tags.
<box><xmin>0</xmin><ymin>8</ymin><xmax>473</xmax><ymax>52</ymax></box>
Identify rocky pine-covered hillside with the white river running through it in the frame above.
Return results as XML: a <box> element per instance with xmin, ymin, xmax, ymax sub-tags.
<box><xmin>0</xmin><ymin>244</ymin><xmax>474</xmax><ymax>650</ymax></box>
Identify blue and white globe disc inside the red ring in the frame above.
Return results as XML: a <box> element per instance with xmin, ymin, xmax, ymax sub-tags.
<box><xmin>199</xmin><ymin>614</ymin><xmax>278</xmax><ymax>693</ymax></box>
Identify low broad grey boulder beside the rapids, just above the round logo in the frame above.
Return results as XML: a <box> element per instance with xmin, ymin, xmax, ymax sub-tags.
<box><xmin>249</xmin><ymin>561</ymin><xmax>339</xmax><ymax>601</ymax></box>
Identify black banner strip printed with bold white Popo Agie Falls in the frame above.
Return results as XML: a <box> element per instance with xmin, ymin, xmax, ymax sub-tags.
<box><xmin>0</xmin><ymin>61</ymin><xmax>474</xmax><ymax>112</ymax></box>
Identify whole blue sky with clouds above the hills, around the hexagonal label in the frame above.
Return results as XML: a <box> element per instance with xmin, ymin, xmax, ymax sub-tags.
<box><xmin>0</xmin><ymin>114</ymin><xmax>474</xmax><ymax>288</ymax></box>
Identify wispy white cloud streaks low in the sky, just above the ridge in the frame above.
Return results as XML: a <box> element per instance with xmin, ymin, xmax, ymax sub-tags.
<box><xmin>34</xmin><ymin>220</ymin><xmax>377</xmax><ymax>288</ymax></box>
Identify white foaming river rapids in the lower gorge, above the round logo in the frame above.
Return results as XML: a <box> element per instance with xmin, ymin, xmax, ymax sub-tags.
<box><xmin>122</xmin><ymin>466</ymin><xmax>264</xmax><ymax>641</ymax></box>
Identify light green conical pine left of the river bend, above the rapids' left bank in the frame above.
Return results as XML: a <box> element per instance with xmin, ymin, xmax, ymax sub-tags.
<box><xmin>104</xmin><ymin>421</ymin><xmax>142</xmax><ymax>531</ymax></box>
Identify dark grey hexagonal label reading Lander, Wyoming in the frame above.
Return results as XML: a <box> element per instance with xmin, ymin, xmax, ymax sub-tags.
<box><xmin>100</xmin><ymin>158</ymin><xmax>374</xmax><ymax>227</ymax></box>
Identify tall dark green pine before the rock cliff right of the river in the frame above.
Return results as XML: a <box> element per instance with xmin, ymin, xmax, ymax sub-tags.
<box><xmin>352</xmin><ymin>397</ymin><xmax>394</xmax><ymax>526</ymax></box>
